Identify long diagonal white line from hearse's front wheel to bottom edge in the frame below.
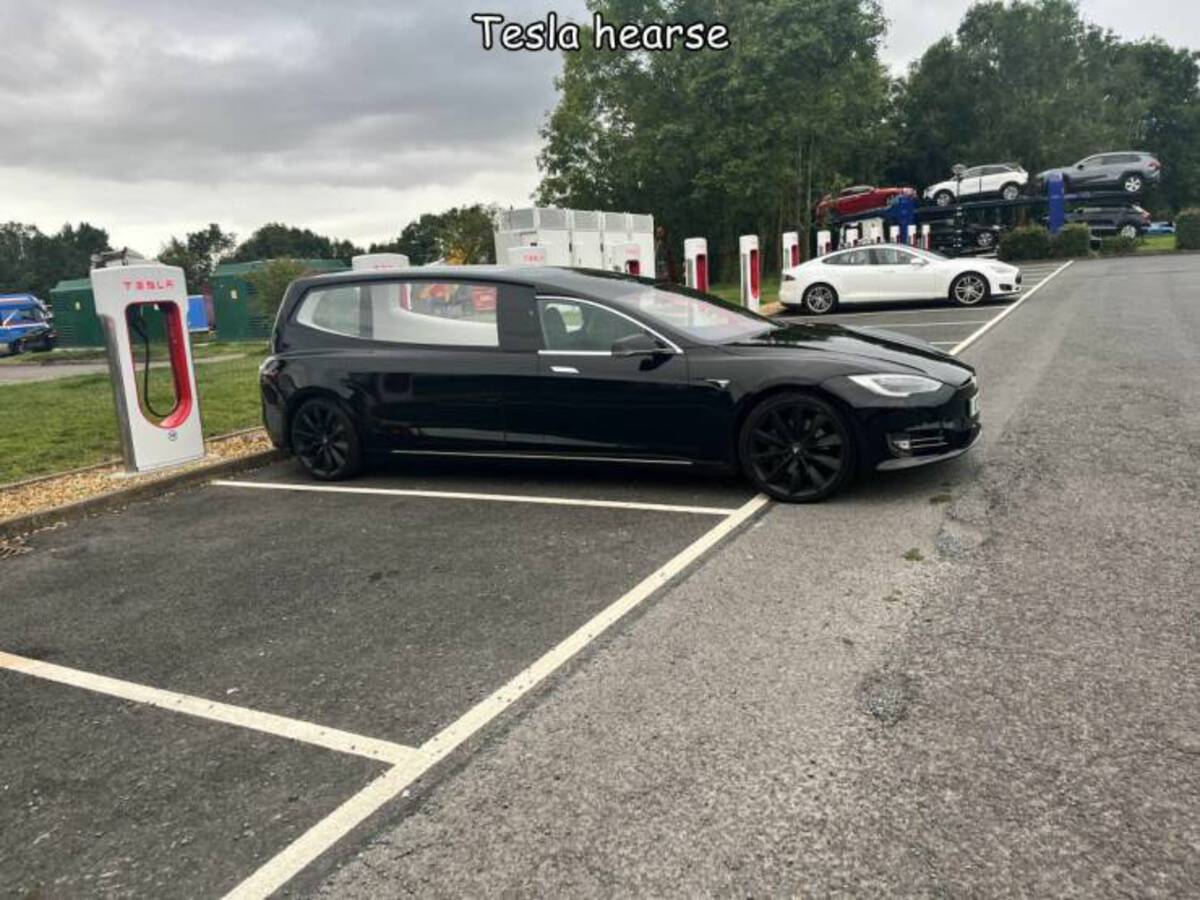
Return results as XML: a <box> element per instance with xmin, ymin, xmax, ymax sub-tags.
<box><xmin>227</xmin><ymin>494</ymin><xmax>768</xmax><ymax>900</ymax></box>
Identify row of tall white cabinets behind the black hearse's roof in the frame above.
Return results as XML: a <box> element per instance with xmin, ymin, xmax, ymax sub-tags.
<box><xmin>494</xmin><ymin>206</ymin><xmax>655</xmax><ymax>277</ymax></box>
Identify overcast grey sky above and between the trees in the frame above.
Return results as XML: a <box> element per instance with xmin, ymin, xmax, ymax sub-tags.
<box><xmin>0</xmin><ymin>0</ymin><xmax>1200</xmax><ymax>254</ymax></box>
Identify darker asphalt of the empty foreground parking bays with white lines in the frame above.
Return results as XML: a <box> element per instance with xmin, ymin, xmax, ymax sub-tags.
<box><xmin>0</xmin><ymin>463</ymin><xmax>766</xmax><ymax>896</ymax></box>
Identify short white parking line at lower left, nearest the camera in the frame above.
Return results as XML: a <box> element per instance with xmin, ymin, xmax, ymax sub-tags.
<box><xmin>0</xmin><ymin>650</ymin><xmax>420</xmax><ymax>766</ymax></box>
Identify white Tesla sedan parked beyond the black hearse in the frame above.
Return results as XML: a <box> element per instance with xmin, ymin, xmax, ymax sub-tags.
<box><xmin>779</xmin><ymin>244</ymin><xmax>1021</xmax><ymax>316</ymax></box>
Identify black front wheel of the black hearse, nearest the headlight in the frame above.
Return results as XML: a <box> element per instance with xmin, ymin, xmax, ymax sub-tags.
<box><xmin>739</xmin><ymin>392</ymin><xmax>854</xmax><ymax>503</ymax></box>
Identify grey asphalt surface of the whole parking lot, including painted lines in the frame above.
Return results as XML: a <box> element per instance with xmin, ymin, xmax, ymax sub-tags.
<box><xmin>0</xmin><ymin>255</ymin><xmax>1200</xmax><ymax>898</ymax></box>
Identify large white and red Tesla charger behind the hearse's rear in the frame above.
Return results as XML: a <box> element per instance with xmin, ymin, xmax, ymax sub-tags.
<box><xmin>91</xmin><ymin>262</ymin><xmax>204</xmax><ymax>472</ymax></box>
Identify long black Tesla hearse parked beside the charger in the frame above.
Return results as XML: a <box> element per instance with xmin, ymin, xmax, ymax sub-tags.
<box><xmin>260</xmin><ymin>266</ymin><xmax>979</xmax><ymax>502</ymax></box>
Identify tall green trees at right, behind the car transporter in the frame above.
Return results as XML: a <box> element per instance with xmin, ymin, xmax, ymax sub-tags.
<box><xmin>536</xmin><ymin>0</ymin><xmax>1200</xmax><ymax>272</ymax></box>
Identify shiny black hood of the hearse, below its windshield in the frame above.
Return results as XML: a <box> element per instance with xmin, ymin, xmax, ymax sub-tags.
<box><xmin>738</xmin><ymin>323</ymin><xmax>974</xmax><ymax>386</ymax></box>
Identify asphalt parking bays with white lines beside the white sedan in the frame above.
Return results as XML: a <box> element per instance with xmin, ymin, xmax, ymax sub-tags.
<box><xmin>776</xmin><ymin>262</ymin><xmax>1066</xmax><ymax>352</ymax></box>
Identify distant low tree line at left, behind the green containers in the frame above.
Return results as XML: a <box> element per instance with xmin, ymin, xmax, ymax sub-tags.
<box><xmin>0</xmin><ymin>204</ymin><xmax>496</xmax><ymax>300</ymax></box>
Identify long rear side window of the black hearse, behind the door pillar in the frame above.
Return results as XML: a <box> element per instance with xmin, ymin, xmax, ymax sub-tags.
<box><xmin>295</xmin><ymin>281</ymin><xmax>500</xmax><ymax>347</ymax></box>
